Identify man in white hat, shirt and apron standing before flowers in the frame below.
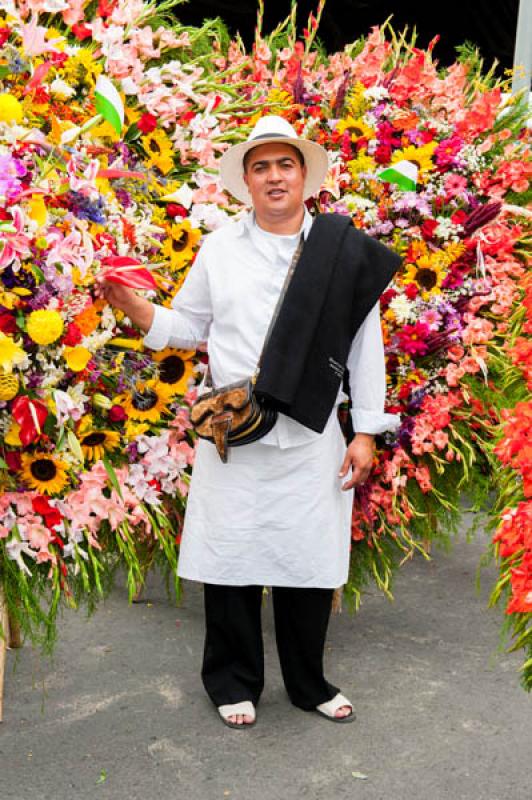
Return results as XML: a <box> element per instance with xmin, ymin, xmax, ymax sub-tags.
<box><xmin>103</xmin><ymin>116</ymin><xmax>396</xmax><ymax>729</ymax></box>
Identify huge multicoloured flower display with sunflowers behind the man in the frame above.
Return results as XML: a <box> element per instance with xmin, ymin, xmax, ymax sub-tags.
<box><xmin>0</xmin><ymin>0</ymin><xmax>531</xmax><ymax>680</ymax></box>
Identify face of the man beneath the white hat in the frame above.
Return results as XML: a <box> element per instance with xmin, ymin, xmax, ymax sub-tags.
<box><xmin>244</xmin><ymin>143</ymin><xmax>307</xmax><ymax>221</ymax></box>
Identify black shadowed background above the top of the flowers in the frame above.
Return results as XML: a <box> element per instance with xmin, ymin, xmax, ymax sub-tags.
<box><xmin>175</xmin><ymin>0</ymin><xmax>519</xmax><ymax>75</ymax></box>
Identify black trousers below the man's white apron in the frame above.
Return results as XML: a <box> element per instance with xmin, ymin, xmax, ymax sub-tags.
<box><xmin>201</xmin><ymin>584</ymin><xmax>339</xmax><ymax>711</ymax></box>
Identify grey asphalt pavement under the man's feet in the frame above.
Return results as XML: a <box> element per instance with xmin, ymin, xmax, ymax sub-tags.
<box><xmin>0</xmin><ymin>524</ymin><xmax>532</xmax><ymax>800</ymax></box>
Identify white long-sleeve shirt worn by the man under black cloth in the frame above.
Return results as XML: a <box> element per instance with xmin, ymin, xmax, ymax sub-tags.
<box><xmin>144</xmin><ymin>210</ymin><xmax>399</xmax><ymax>448</ymax></box>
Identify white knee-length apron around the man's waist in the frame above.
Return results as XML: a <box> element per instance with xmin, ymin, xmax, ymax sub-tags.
<box><xmin>178</xmin><ymin>408</ymin><xmax>353</xmax><ymax>588</ymax></box>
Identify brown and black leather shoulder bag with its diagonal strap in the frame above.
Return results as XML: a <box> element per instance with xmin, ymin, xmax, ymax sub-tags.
<box><xmin>190</xmin><ymin>235</ymin><xmax>304</xmax><ymax>464</ymax></box>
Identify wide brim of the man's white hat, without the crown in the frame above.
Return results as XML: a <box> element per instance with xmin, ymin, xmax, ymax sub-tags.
<box><xmin>218</xmin><ymin>135</ymin><xmax>329</xmax><ymax>206</ymax></box>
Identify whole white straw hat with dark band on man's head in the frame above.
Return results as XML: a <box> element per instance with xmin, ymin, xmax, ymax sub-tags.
<box><xmin>219</xmin><ymin>114</ymin><xmax>329</xmax><ymax>205</ymax></box>
